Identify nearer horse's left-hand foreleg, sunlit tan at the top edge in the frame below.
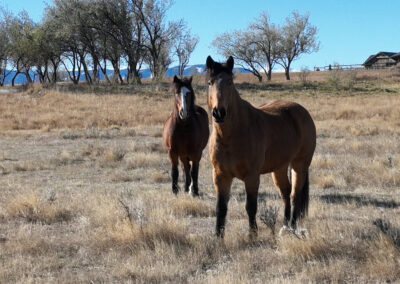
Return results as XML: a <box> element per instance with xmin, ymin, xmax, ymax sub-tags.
<box><xmin>213</xmin><ymin>170</ymin><xmax>232</xmax><ymax>238</ymax></box>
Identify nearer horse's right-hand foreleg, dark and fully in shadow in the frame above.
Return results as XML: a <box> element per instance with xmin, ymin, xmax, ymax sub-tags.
<box><xmin>245</xmin><ymin>176</ymin><xmax>260</xmax><ymax>237</ymax></box>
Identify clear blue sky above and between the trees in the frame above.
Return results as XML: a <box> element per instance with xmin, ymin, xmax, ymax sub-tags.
<box><xmin>0</xmin><ymin>0</ymin><xmax>400</xmax><ymax>69</ymax></box>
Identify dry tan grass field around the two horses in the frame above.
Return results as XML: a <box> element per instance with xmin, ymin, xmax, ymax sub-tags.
<box><xmin>0</xmin><ymin>71</ymin><xmax>400</xmax><ymax>283</ymax></box>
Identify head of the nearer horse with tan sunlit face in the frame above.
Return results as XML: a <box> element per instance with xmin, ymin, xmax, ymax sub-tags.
<box><xmin>206</xmin><ymin>56</ymin><xmax>235</xmax><ymax>123</ymax></box>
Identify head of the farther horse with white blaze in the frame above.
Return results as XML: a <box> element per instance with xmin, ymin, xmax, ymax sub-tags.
<box><xmin>172</xmin><ymin>76</ymin><xmax>194</xmax><ymax>120</ymax></box>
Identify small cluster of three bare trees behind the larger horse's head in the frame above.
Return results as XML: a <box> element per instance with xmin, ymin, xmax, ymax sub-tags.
<box><xmin>212</xmin><ymin>12</ymin><xmax>319</xmax><ymax>82</ymax></box>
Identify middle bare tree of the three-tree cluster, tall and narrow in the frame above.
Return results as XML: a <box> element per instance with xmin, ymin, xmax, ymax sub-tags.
<box><xmin>249</xmin><ymin>12</ymin><xmax>280</xmax><ymax>80</ymax></box>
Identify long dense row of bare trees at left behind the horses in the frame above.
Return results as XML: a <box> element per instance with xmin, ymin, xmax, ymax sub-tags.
<box><xmin>0</xmin><ymin>0</ymin><xmax>199</xmax><ymax>85</ymax></box>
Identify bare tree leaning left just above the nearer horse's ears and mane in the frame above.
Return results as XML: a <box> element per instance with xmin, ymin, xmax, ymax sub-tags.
<box><xmin>212</xmin><ymin>31</ymin><xmax>266</xmax><ymax>82</ymax></box>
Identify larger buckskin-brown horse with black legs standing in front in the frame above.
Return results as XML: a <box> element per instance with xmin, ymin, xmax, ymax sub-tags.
<box><xmin>206</xmin><ymin>56</ymin><xmax>316</xmax><ymax>237</ymax></box>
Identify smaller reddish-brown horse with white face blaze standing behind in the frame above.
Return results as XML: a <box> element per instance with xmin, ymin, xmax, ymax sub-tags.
<box><xmin>163</xmin><ymin>76</ymin><xmax>210</xmax><ymax>196</ymax></box>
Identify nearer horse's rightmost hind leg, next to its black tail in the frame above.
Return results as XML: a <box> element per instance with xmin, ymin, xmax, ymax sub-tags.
<box><xmin>289</xmin><ymin>164</ymin><xmax>309</xmax><ymax>229</ymax></box>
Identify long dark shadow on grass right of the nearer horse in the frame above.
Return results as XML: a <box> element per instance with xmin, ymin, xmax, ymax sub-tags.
<box><xmin>319</xmin><ymin>193</ymin><xmax>400</xmax><ymax>208</ymax></box>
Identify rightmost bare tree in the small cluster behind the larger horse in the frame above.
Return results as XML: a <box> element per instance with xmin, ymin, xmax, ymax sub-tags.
<box><xmin>278</xmin><ymin>12</ymin><xmax>319</xmax><ymax>80</ymax></box>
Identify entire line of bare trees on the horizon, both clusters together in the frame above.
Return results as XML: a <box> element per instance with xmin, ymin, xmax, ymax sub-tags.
<box><xmin>0</xmin><ymin>0</ymin><xmax>319</xmax><ymax>86</ymax></box>
